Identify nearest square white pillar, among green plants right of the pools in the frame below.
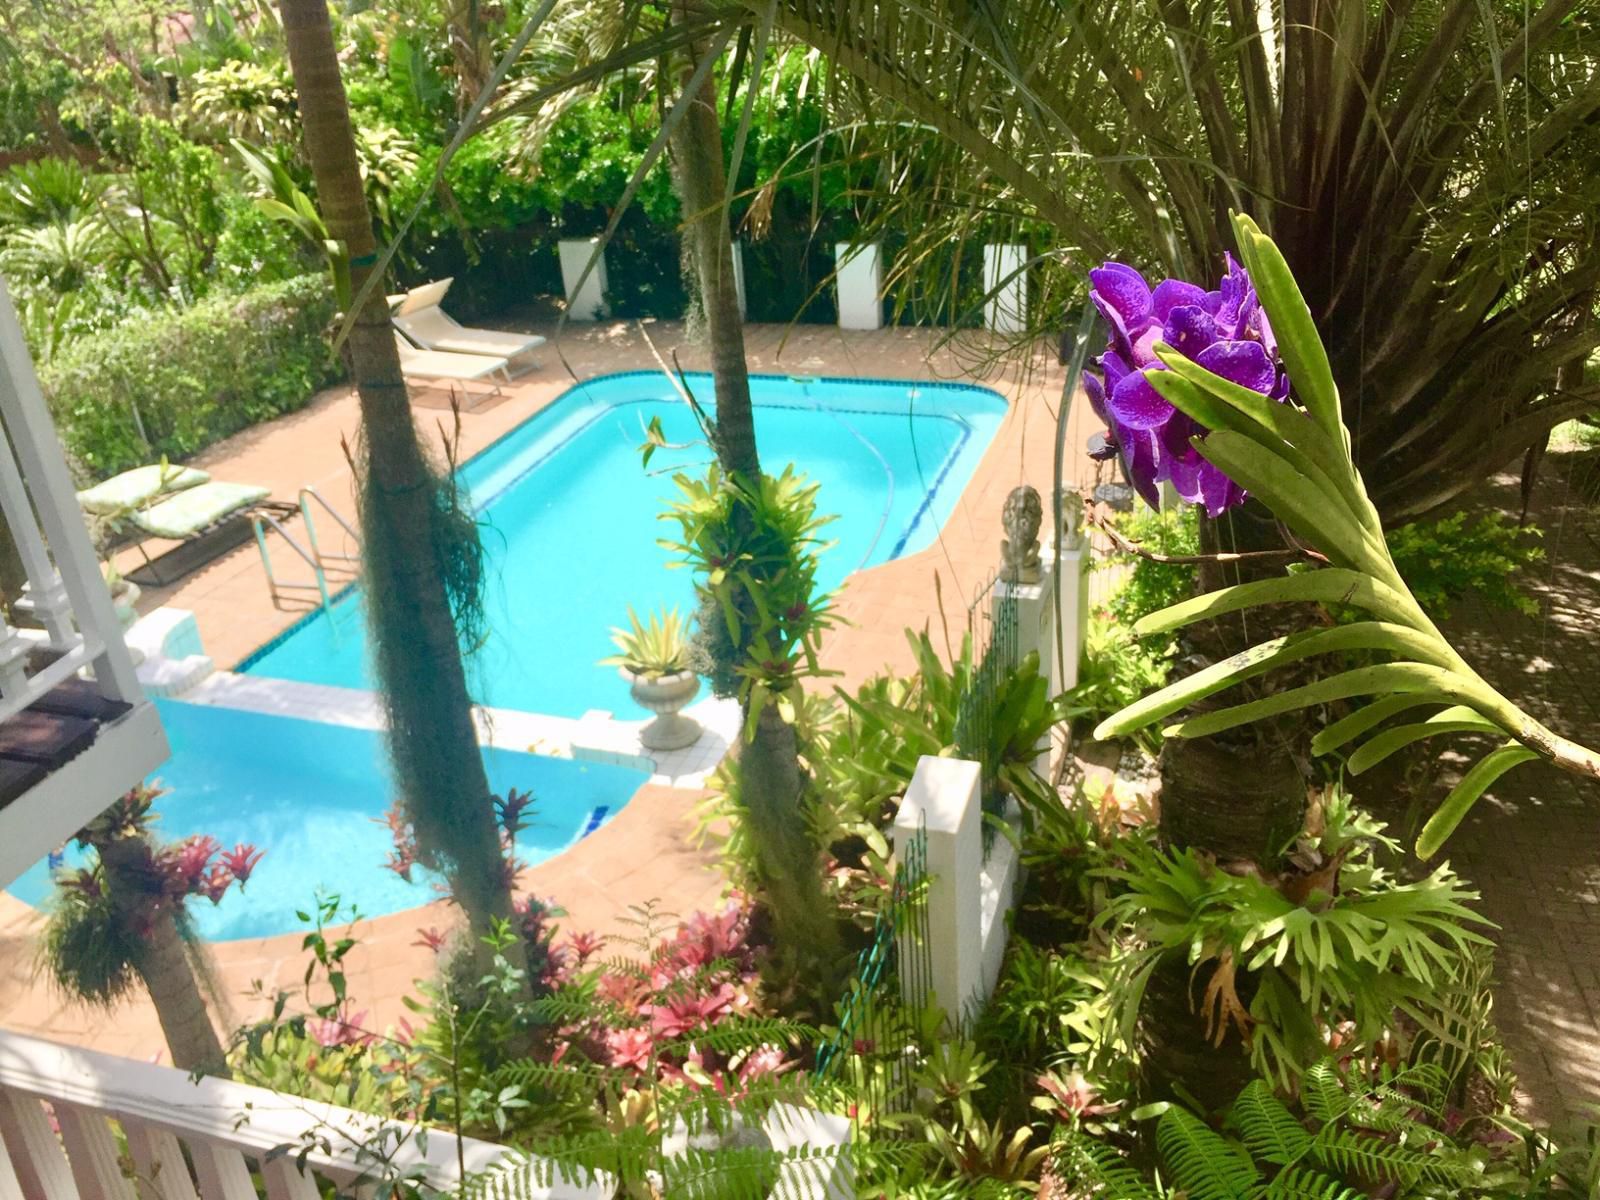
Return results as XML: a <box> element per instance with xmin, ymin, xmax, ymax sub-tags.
<box><xmin>894</xmin><ymin>755</ymin><xmax>984</xmax><ymax>1027</ymax></box>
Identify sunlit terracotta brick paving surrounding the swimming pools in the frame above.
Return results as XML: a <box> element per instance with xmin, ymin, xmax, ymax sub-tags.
<box><xmin>0</xmin><ymin>322</ymin><xmax>1093</xmax><ymax>1058</ymax></box>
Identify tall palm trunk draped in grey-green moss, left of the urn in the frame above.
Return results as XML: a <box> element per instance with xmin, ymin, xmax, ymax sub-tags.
<box><xmin>282</xmin><ymin>0</ymin><xmax>520</xmax><ymax>962</ymax></box>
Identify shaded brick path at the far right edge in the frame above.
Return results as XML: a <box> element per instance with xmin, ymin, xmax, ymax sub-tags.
<box><xmin>1445</xmin><ymin>451</ymin><xmax>1600</xmax><ymax>1126</ymax></box>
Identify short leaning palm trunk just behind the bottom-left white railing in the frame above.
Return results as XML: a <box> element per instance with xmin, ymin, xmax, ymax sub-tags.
<box><xmin>91</xmin><ymin>834</ymin><xmax>229</xmax><ymax>1078</ymax></box>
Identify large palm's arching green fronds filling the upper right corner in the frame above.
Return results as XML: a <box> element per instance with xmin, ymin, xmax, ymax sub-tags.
<box><xmin>739</xmin><ymin>0</ymin><xmax>1600</xmax><ymax>518</ymax></box>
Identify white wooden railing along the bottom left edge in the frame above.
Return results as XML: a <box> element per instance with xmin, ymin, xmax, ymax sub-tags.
<box><xmin>0</xmin><ymin>1034</ymin><xmax>854</xmax><ymax>1200</ymax></box>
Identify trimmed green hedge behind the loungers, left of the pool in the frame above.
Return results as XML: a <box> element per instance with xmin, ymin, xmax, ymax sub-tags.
<box><xmin>42</xmin><ymin>275</ymin><xmax>341</xmax><ymax>480</ymax></box>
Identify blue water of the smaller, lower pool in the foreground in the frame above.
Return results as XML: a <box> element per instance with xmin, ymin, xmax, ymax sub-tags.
<box><xmin>10</xmin><ymin>701</ymin><xmax>650</xmax><ymax>941</ymax></box>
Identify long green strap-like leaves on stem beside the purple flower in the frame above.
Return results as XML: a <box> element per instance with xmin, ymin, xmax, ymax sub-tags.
<box><xmin>1094</xmin><ymin>214</ymin><xmax>1600</xmax><ymax>858</ymax></box>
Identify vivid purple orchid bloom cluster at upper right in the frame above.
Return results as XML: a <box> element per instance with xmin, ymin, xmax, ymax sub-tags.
<box><xmin>1083</xmin><ymin>254</ymin><xmax>1290</xmax><ymax>517</ymax></box>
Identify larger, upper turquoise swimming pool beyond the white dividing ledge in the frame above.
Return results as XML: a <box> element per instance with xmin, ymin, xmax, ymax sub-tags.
<box><xmin>238</xmin><ymin>371</ymin><xmax>1006</xmax><ymax>717</ymax></box>
